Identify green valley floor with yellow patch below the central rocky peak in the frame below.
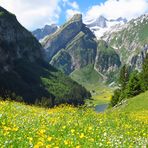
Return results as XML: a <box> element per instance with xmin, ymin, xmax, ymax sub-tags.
<box><xmin>71</xmin><ymin>65</ymin><xmax>113</xmax><ymax>105</ymax></box>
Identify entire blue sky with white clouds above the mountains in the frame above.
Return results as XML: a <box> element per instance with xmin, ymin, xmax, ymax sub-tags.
<box><xmin>0</xmin><ymin>0</ymin><xmax>148</xmax><ymax>31</ymax></box>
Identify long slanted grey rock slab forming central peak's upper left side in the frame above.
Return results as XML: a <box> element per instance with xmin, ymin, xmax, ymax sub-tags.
<box><xmin>42</xmin><ymin>15</ymin><xmax>82</xmax><ymax>60</ymax></box>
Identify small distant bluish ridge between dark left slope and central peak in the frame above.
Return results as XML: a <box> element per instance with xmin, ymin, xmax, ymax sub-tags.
<box><xmin>32</xmin><ymin>24</ymin><xmax>58</xmax><ymax>40</ymax></box>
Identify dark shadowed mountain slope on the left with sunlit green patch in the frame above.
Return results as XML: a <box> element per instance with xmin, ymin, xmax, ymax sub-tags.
<box><xmin>0</xmin><ymin>7</ymin><xmax>90</xmax><ymax>106</ymax></box>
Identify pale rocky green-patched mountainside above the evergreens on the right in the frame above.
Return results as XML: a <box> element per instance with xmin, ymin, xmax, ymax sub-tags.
<box><xmin>102</xmin><ymin>14</ymin><xmax>148</xmax><ymax>70</ymax></box>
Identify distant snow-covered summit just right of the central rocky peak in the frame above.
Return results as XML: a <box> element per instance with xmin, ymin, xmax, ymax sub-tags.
<box><xmin>84</xmin><ymin>15</ymin><xmax>127</xmax><ymax>39</ymax></box>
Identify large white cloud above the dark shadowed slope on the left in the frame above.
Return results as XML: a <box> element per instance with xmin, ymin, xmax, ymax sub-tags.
<box><xmin>0</xmin><ymin>0</ymin><xmax>61</xmax><ymax>30</ymax></box>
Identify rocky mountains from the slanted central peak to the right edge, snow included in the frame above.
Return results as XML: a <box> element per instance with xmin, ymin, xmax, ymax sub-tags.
<box><xmin>36</xmin><ymin>14</ymin><xmax>148</xmax><ymax>85</ymax></box>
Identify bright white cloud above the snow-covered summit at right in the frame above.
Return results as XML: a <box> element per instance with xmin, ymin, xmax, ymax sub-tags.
<box><xmin>85</xmin><ymin>0</ymin><xmax>148</xmax><ymax>20</ymax></box>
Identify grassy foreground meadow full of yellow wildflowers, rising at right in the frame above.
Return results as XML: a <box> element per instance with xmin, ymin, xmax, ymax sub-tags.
<box><xmin>0</xmin><ymin>92</ymin><xmax>148</xmax><ymax>148</ymax></box>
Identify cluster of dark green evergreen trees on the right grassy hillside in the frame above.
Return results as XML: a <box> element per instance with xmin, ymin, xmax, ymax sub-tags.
<box><xmin>110</xmin><ymin>54</ymin><xmax>148</xmax><ymax>106</ymax></box>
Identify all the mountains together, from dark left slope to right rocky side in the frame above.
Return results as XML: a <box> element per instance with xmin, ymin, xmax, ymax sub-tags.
<box><xmin>0</xmin><ymin>4</ymin><xmax>148</xmax><ymax>106</ymax></box>
